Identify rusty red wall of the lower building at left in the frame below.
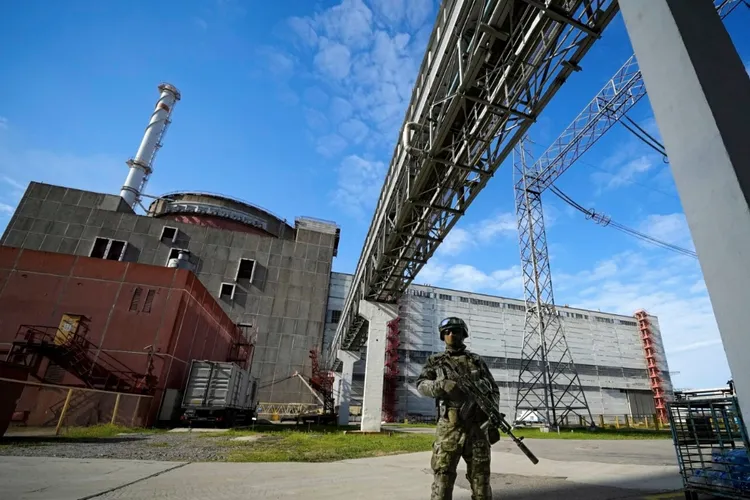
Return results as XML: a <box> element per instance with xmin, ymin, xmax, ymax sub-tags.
<box><xmin>0</xmin><ymin>247</ymin><xmax>250</xmax><ymax>421</ymax></box>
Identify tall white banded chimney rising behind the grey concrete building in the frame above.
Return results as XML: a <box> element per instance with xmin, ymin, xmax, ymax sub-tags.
<box><xmin>120</xmin><ymin>83</ymin><xmax>180</xmax><ymax>210</ymax></box>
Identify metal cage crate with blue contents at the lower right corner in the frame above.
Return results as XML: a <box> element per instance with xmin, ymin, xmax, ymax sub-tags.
<box><xmin>667</xmin><ymin>396</ymin><xmax>750</xmax><ymax>499</ymax></box>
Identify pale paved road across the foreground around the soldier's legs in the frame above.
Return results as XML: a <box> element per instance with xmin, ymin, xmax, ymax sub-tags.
<box><xmin>0</xmin><ymin>440</ymin><xmax>681</xmax><ymax>500</ymax></box>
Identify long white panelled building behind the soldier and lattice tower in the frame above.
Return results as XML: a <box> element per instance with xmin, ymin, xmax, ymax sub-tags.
<box><xmin>324</xmin><ymin>273</ymin><xmax>673</xmax><ymax>421</ymax></box>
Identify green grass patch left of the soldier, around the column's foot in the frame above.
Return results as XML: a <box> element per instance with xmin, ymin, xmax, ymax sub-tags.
<box><xmin>213</xmin><ymin>426</ymin><xmax>433</xmax><ymax>462</ymax></box>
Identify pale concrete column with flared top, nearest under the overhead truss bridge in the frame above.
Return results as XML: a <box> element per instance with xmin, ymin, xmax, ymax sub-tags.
<box><xmin>359</xmin><ymin>301</ymin><xmax>397</xmax><ymax>432</ymax></box>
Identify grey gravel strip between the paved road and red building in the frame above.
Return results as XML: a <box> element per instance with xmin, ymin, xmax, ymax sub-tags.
<box><xmin>0</xmin><ymin>432</ymin><xmax>230</xmax><ymax>462</ymax></box>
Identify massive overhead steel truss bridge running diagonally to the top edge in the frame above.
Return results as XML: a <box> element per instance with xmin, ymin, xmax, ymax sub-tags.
<box><xmin>328</xmin><ymin>0</ymin><xmax>618</xmax><ymax>366</ymax></box>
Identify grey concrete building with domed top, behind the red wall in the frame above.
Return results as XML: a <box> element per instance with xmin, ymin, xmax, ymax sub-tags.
<box><xmin>0</xmin><ymin>182</ymin><xmax>339</xmax><ymax>403</ymax></box>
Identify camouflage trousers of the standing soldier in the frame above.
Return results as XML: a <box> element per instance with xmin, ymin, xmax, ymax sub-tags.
<box><xmin>430</xmin><ymin>409</ymin><xmax>492</xmax><ymax>500</ymax></box>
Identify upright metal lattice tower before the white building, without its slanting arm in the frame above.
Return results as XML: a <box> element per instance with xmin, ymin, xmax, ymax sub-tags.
<box><xmin>514</xmin><ymin>141</ymin><xmax>593</xmax><ymax>427</ymax></box>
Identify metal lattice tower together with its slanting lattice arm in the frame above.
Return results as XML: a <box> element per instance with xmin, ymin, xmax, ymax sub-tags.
<box><xmin>514</xmin><ymin>0</ymin><xmax>745</xmax><ymax>426</ymax></box>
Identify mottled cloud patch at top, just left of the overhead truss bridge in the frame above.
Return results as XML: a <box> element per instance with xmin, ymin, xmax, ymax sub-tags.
<box><xmin>274</xmin><ymin>0</ymin><xmax>434</xmax><ymax>159</ymax></box>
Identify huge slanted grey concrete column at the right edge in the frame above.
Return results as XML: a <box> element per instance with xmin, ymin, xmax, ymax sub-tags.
<box><xmin>620</xmin><ymin>0</ymin><xmax>750</xmax><ymax>421</ymax></box>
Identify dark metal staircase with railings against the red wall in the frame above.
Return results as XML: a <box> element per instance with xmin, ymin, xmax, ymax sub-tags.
<box><xmin>7</xmin><ymin>325</ymin><xmax>156</xmax><ymax>394</ymax></box>
